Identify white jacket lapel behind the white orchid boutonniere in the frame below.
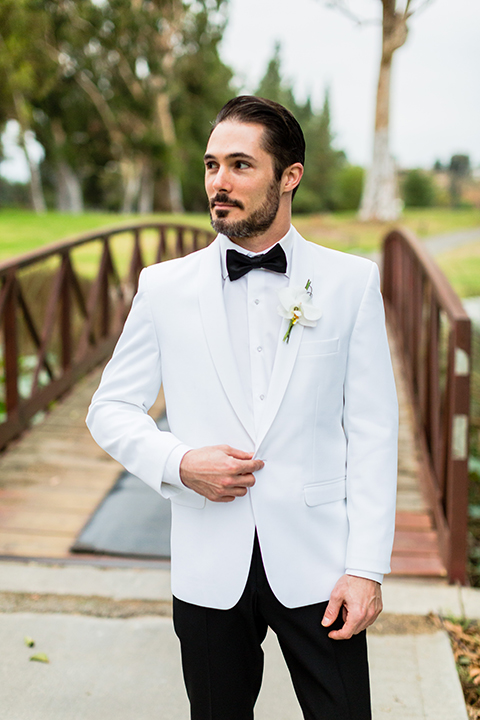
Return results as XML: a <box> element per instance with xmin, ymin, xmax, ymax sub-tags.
<box><xmin>256</xmin><ymin>231</ymin><xmax>315</xmax><ymax>452</ymax></box>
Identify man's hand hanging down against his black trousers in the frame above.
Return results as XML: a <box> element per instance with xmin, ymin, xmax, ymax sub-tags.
<box><xmin>322</xmin><ymin>575</ymin><xmax>383</xmax><ymax>640</ymax></box>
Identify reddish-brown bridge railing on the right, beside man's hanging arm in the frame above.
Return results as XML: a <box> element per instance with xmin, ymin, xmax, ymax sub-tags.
<box><xmin>383</xmin><ymin>229</ymin><xmax>471</xmax><ymax>583</ymax></box>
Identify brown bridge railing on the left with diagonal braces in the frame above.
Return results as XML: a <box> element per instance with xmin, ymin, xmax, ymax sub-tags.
<box><xmin>0</xmin><ymin>222</ymin><xmax>214</xmax><ymax>450</ymax></box>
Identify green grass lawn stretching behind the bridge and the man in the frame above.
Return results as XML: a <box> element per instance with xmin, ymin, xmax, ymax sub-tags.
<box><xmin>0</xmin><ymin>208</ymin><xmax>480</xmax><ymax>296</ymax></box>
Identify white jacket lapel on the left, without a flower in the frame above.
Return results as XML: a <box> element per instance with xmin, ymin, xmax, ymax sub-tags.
<box><xmin>199</xmin><ymin>240</ymin><xmax>255</xmax><ymax>441</ymax></box>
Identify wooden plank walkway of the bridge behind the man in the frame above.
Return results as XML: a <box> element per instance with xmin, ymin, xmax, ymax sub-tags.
<box><xmin>0</xmin><ymin>324</ymin><xmax>446</xmax><ymax>577</ymax></box>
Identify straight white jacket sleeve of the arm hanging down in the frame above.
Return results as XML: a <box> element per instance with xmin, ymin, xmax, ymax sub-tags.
<box><xmin>344</xmin><ymin>264</ymin><xmax>398</xmax><ymax>574</ymax></box>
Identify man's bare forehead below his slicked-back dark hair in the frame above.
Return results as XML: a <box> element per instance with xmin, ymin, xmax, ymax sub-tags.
<box><xmin>206</xmin><ymin>120</ymin><xmax>270</xmax><ymax>160</ymax></box>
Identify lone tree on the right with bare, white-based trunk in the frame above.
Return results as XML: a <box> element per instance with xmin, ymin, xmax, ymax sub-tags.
<box><xmin>329</xmin><ymin>0</ymin><xmax>431</xmax><ymax>220</ymax></box>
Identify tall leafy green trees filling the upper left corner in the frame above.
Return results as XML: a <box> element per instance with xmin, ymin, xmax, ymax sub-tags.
<box><xmin>0</xmin><ymin>0</ymin><xmax>234</xmax><ymax>210</ymax></box>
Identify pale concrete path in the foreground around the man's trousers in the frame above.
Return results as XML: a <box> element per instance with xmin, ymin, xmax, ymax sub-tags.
<box><xmin>0</xmin><ymin>562</ymin><xmax>468</xmax><ymax>720</ymax></box>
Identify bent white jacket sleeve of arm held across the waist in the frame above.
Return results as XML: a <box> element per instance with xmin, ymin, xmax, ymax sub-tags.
<box><xmin>86</xmin><ymin>270</ymin><xmax>190</xmax><ymax>497</ymax></box>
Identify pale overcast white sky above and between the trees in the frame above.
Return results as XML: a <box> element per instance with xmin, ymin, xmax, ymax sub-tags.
<box><xmin>0</xmin><ymin>0</ymin><xmax>480</xmax><ymax>180</ymax></box>
